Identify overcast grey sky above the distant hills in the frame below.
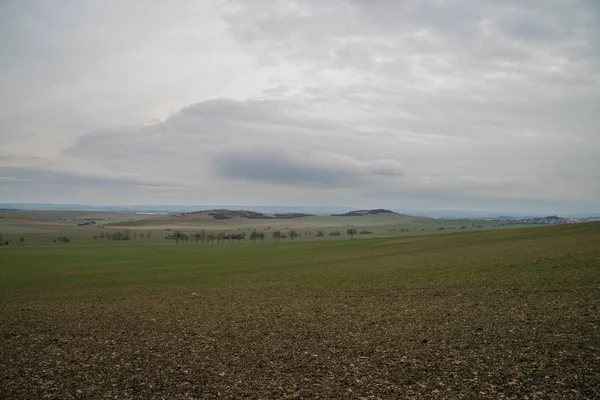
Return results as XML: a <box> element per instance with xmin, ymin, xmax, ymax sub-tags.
<box><xmin>0</xmin><ymin>0</ymin><xmax>600</xmax><ymax>213</ymax></box>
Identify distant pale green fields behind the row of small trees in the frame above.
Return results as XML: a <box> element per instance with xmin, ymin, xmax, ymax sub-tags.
<box><xmin>0</xmin><ymin>210</ymin><xmax>527</xmax><ymax>246</ymax></box>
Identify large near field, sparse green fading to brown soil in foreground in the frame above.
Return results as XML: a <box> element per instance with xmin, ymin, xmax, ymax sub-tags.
<box><xmin>0</xmin><ymin>223</ymin><xmax>600</xmax><ymax>399</ymax></box>
